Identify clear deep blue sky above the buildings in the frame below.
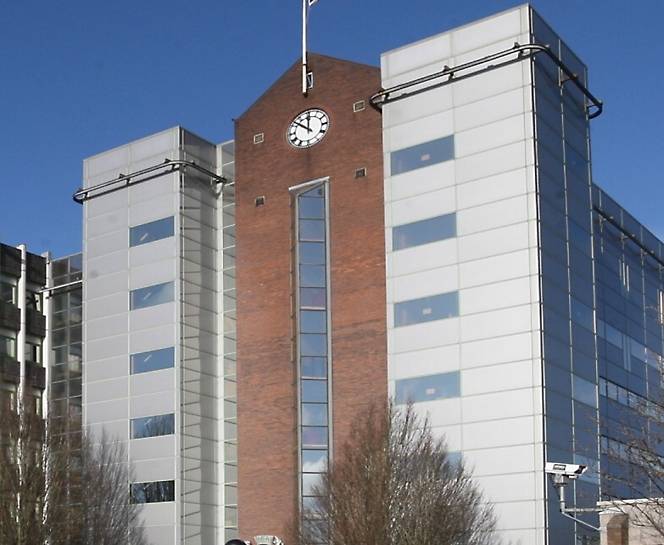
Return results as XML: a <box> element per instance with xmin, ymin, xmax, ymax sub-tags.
<box><xmin>0</xmin><ymin>0</ymin><xmax>664</xmax><ymax>256</ymax></box>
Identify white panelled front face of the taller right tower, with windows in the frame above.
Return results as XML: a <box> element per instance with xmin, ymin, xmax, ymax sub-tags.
<box><xmin>381</xmin><ymin>6</ymin><xmax>544</xmax><ymax>544</ymax></box>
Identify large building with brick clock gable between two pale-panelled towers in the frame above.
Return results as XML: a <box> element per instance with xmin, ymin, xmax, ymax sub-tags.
<box><xmin>76</xmin><ymin>5</ymin><xmax>664</xmax><ymax>545</ymax></box>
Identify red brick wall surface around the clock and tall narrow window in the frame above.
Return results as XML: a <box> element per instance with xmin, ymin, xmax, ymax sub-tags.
<box><xmin>235</xmin><ymin>54</ymin><xmax>387</xmax><ymax>539</ymax></box>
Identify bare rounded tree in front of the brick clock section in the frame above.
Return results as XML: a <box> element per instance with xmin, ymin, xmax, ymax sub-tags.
<box><xmin>291</xmin><ymin>402</ymin><xmax>496</xmax><ymax>545</ymax></box>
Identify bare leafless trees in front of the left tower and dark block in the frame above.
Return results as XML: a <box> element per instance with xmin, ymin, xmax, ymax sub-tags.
<box><xmin>0</xmin><ymin>410</ymin><xmax>146</xmax><ymax>545</ymax></box>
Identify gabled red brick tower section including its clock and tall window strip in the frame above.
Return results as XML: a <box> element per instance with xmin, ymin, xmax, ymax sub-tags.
<box><xmin>235</xmin><ymin>54</ymin><xmax>387</xmax><ymax>536</ymax></box>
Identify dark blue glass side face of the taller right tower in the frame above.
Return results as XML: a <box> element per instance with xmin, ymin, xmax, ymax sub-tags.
<box><xmin>533</xmin><ymin>11</ymin><xmax>599</xmax><ymax>543</ymax></box>
